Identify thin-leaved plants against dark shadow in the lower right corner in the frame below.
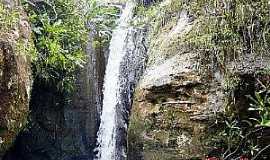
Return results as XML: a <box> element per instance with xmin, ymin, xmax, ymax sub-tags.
<box><xmin>205</xmin><ymin>75</ymin><xmax>270</xmax><ymax>160</ymax></box>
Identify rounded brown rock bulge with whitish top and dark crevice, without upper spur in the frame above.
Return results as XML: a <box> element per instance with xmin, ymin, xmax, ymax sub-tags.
<box><xmin>128</xmin><ymin>54</ymin><xmax>223</xmax><ymax>160</ymax></box>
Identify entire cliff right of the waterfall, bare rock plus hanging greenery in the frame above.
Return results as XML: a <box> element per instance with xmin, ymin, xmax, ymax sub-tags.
<box><xmin>129</xmin><ymin>0</ymin><xmax>269</xmax><ymax>159</ymax></box>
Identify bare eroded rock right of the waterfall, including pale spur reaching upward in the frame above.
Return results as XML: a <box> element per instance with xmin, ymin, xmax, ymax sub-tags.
<box><xmin>128</xmin><ymin>9</ymin><xmax>224</xmax><ymax>160</ymax></box>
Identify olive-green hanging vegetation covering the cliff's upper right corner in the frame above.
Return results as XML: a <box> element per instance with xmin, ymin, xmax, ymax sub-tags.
<box><xmin>186</xmin><ymin>0</ymin><xmax>270</xmax><ymax>72</ymax></box>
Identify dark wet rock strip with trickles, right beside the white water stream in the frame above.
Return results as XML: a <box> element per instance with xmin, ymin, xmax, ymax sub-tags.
<box><xmin>116</xmin><ymin>28</ymin><xmax>147</xmax><ymax>160</ymax></box>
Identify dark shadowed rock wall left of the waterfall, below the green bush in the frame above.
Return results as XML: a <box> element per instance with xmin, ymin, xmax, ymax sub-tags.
<box><xmin>3</xmin><ymin>25</ymin><xmax>106</xmax><ymax>160</ymax></box>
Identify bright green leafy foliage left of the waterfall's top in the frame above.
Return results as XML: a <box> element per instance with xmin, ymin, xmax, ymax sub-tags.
<box><xmin>24</xmin><ymin>0</ymin><xmax>119</xmax><ymax>93</ymax></box>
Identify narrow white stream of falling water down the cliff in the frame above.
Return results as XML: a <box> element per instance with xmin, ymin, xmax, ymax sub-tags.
<box><xmin>97</xmin><ymin>2</ymin><xmax>134</xmax><ymax>160</ymax></box>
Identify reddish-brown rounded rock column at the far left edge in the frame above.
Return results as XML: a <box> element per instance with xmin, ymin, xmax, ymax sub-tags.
<box><xmin>0</xmin><ymin>1</ymin><xmax>32</xmax><ymax>159</ymax></box>
